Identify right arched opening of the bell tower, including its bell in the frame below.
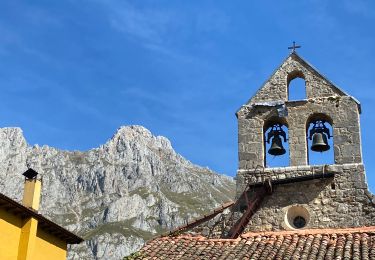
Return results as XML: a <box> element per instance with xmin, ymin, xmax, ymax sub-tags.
<box><xmin>306</xmin><ymin>114</ymin><xmax>335</xmax><ymax>165</ymax></box>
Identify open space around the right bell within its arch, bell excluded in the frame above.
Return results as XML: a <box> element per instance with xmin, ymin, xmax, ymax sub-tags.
<box><xmin>305</xmin><ymin>113</ymin><xmax>335</xmax><ymax>165</ymax></box>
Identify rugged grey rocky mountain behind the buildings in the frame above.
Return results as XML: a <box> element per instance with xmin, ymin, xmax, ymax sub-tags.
<box><xmin>0</xmin><ymin>126</ymin><xmax>235</xmax><ymax>259</ymax></box>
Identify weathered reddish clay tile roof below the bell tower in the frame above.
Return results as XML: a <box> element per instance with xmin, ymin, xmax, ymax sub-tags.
<box><xmin>129</xmin><ymin>226</ymin><xmax>375</xmax><ymax>260</ymax></box>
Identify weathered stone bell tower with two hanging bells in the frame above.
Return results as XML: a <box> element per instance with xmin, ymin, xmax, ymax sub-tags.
<box><xmin>236</xmin><ymin>49</ymin><xmax>375</xmax><ymax>231</ymax></box>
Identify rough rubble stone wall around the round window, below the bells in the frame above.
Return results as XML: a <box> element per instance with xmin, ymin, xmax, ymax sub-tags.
<box><xmin>238</xmin><ymin>164</ymin><xmax>375</xmax><ymax>232</ymax></box>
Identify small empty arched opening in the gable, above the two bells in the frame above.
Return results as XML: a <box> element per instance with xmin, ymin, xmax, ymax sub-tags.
<box><xmin>287</xmin><ymin>71</ymin><xmax>307</xmax><ymax>101</ymax></box>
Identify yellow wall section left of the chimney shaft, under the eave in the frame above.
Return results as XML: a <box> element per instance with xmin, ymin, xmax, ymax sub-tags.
<box><xmin>0</xmin><ymin>209</ymin><xmax>22</xmax><ymax>260</ymax></box>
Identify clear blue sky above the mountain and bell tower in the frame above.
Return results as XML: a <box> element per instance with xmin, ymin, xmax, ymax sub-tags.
<box><xmin>0</xmin><ymin>0</ymin><xmax>375</xmax><ymax>190</ymax></box>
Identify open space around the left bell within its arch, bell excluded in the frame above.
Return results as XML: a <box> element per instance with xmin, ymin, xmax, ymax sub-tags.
<box><xmin>263</xmin><ymin>116</ymin><xmax>289</xmax><ymax>167</ymax></box>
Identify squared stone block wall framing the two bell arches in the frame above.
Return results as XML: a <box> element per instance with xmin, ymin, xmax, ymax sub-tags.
<box><xmin>237</xmin><ymin>96</ymin><xmax>362</xmax><ymax>169</ymax></box>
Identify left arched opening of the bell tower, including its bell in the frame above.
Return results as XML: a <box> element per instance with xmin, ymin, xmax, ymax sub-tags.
<box><xmin>263</xmin><ymin>118</ymin><xmax>289</xmax><ymax>167</ymax></box>
